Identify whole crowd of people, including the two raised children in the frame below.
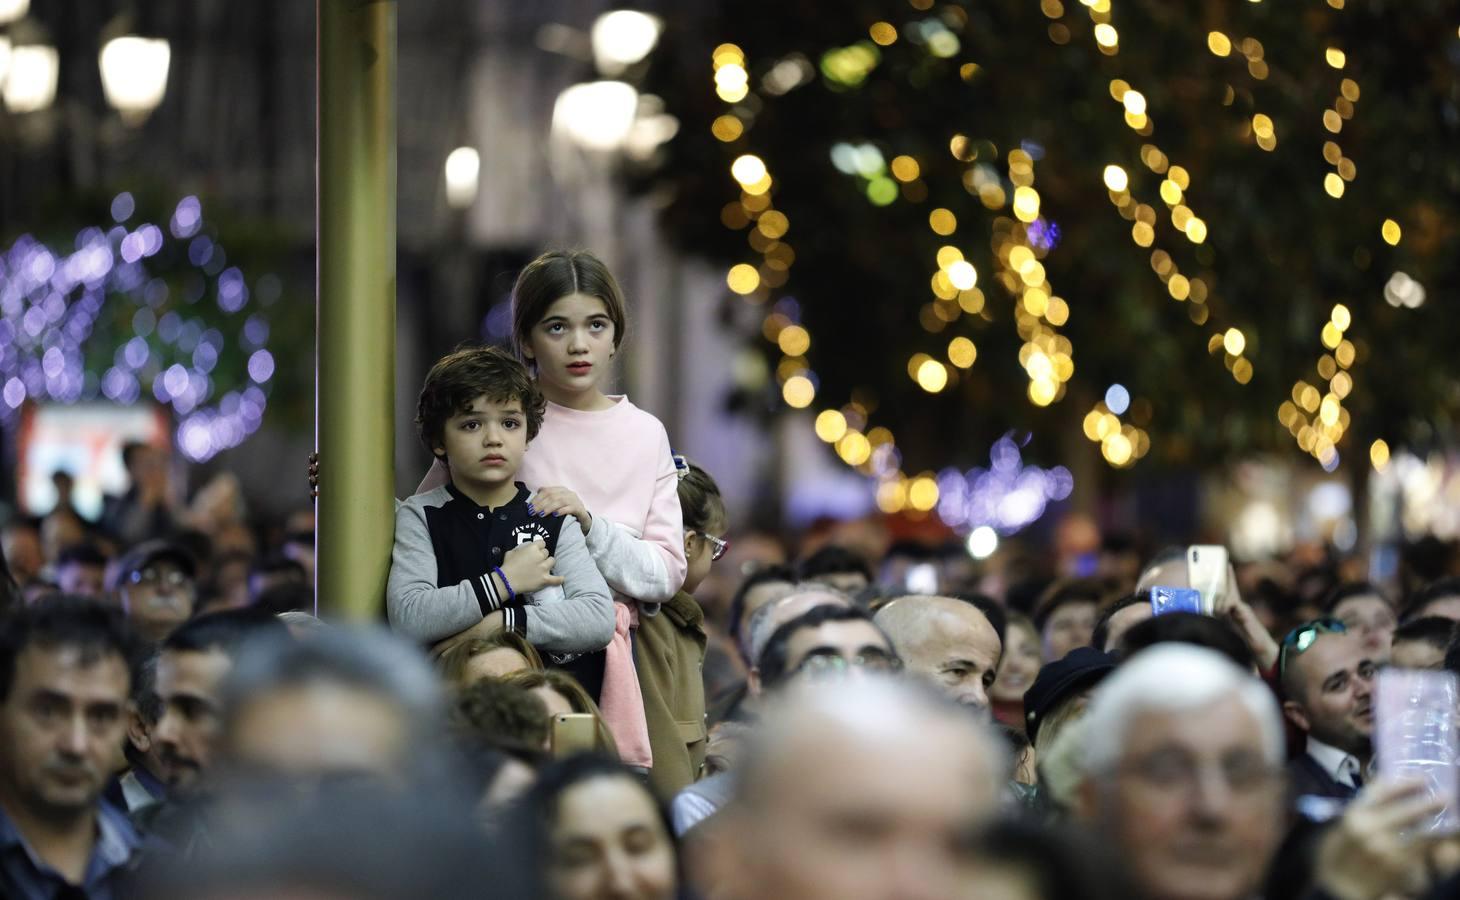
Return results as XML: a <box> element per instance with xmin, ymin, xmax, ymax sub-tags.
<box><xmin>0</xmin><ymin>253</ymin><xmax>1460</xmax><ymax>900</ymax></box>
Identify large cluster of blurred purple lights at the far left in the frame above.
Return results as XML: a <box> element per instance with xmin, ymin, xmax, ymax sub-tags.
<box><xmin>0</xmin><ymin>193</ymin><xmax>282</xmax><ymax>462</ymax></box>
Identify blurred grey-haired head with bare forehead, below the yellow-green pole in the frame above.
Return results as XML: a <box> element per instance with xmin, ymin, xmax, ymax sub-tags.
<box><xmin>219</xmin><ymin>628</ymin><xmax>444</xmax><ymax>780</ymax></box>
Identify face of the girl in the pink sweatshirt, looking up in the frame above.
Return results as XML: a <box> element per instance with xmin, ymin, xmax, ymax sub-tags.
<box><xmin>526</xmin><ymin>294</ymin><xmax>613</xmax><ymax>396</ymax></box>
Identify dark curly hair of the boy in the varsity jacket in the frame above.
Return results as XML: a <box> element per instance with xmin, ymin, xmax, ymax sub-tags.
<box><xmin>416</xmin><ymin>346</ymin><xmax>548</xmax><ymax>456</ymax></box>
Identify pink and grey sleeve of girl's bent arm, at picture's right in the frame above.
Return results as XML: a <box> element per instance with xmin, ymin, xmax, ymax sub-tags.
<box><xmin>588</xmin><ymin>423</ymin><xmax>688</xmax><ymax>603</ymax></box>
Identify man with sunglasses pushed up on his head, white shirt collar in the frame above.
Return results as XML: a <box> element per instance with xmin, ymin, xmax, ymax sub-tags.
<box><xmin>1278</xmin><ymin>618</ymin><xmax>1377</xmax><ymax>799</ymax></box>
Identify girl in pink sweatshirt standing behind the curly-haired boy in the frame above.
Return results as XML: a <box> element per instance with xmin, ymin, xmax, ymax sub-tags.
<box><xmin>422</xmin><ymin>251</ymin><xmax>686</xmax><ymax>769</ymax></box>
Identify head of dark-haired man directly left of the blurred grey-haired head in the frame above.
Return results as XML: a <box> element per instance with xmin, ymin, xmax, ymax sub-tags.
<box><xmin>152</xmin><ymin>609</ymin><xmax>283</xmax><ymax>790</ymax></box>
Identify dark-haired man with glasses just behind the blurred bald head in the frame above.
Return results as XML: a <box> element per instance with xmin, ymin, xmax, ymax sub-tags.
<box><xmin>670</xmin><ymin>605</ymin><xmax>902</xmax><ymax>834</ymax></box>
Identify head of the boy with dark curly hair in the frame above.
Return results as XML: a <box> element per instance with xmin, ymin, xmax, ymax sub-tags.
<box><xmin>416</xmin><ymin>346</ymin><xmax>546</xmax><ymax>491</ymax></box>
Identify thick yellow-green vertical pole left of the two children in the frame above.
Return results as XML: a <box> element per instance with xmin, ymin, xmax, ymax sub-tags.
<box><xmin>315</xmin><ymin>0</ymin><xmax>396</xmax><ymax>621</ymax></box>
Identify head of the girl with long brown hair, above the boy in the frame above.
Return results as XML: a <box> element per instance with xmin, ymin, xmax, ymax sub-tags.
<box><xmin>512</xmin><ymin>250</ymin><xmax>628</xmax><ymax>405</ymax></box>
